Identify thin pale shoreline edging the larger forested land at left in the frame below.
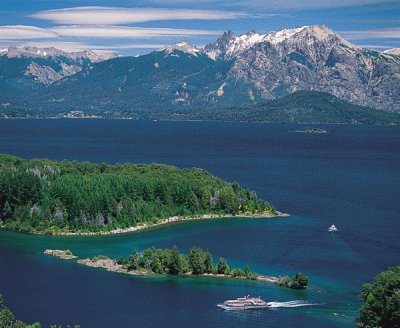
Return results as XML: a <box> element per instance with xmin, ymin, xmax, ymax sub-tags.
<box><xmin>1</xmin><ymin>211</ymin><xmax>290</xmax><ymax>236</ymax></box>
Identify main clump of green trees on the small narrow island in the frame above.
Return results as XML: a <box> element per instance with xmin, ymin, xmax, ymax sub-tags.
<box><xmin>115</xmin><ymin>246</ymin><xmax>257</xmax><ymax>280</ymax></box>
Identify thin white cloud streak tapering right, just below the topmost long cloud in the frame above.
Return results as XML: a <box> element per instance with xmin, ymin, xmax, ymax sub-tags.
<box><xmin>51</xmin><ymin>25</ymin><xmax>220</xmax><ymax>39</ymax></box>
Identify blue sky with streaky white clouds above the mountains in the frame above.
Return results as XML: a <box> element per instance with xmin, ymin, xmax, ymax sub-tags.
<box><xmin>0</xmin><ymin>0</ymin><xmax>400</xmax><ymax>55</ymax></box>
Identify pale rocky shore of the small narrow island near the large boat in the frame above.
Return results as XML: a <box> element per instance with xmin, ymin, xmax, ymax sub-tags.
<box><xmin>43</xmin><ymin>249</ymin><xmax>279</xmax><ymax>284</ymax></box>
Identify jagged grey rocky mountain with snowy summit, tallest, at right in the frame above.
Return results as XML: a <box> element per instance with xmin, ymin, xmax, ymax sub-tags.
<box><xmin>205</xmin><ymin>26</ymin><xmax>400</xmax><ymax>111</ymax></box>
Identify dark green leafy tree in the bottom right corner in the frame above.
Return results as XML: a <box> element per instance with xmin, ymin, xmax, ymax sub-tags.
<box><xmin>360</xmin><ymin>266</ymin><xmax>400</xmax><ymax>328</ymax></box>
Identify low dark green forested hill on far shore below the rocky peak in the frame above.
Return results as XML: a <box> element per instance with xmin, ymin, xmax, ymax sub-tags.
<box><xmin>148</xmin><ymin>91</ymin><xmax>400</xmax><ymax>124</ymax></box>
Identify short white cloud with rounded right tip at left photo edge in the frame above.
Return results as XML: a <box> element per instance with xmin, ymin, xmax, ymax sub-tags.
<box><xmin>0</xmin><ymin>25</ymin><xmax>58</xmax><ymax>40</ymax></box>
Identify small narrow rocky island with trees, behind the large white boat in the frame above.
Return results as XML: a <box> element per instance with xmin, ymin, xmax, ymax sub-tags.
<box><xmin>44</xmin><ymin>246</ymin><xmax>308</xmax><ymax>289</ymax></box>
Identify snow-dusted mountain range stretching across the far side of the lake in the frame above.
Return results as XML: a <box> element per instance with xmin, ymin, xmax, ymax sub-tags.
<box><xmin>0</xmin><ymin>26</ymin><xmax>400</xmax><ymax>122</ymax></box>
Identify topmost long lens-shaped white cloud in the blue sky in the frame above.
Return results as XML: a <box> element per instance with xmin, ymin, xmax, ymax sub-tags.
<box><xmin>30</xmin><ymin>7</ymin><xmax>248</xmax><ymax>25</ymax></box>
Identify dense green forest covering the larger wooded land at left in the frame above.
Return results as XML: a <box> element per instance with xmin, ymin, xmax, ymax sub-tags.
<box><xmin>0</xmin><ymin>155</ymin><xmax>276</xmax><ymax>234</ymax></box>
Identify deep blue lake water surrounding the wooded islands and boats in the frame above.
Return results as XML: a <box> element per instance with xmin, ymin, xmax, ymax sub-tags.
<box><xmin>0</xmin><ymin>120</ymin><xmax>400</xmax><ymax>327</ymax></box>
